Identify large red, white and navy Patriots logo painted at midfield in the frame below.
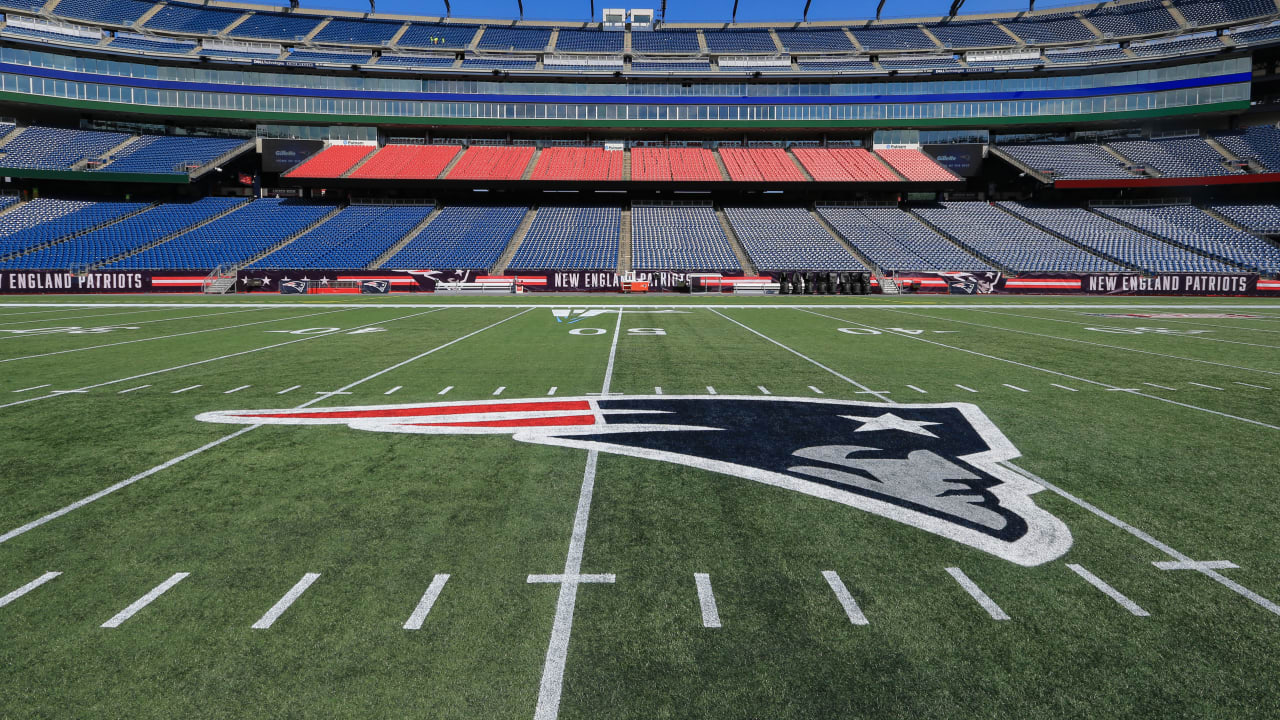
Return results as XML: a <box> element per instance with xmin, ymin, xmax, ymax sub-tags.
<box><xmin>196</xmin><ymin>395</ymin><xmax>1071</xmax><ymax>566</ymax></box>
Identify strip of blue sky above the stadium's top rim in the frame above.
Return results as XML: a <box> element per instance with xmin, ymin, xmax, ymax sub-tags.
<box><xmin>296</xmin><ymin>0</ymin><xmax>1069</xmax><ymax>23</ymax></box>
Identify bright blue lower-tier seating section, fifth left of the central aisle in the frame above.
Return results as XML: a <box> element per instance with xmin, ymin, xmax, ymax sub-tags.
<box><xmin>0</xmin><ymin>197</ymin><xmax>244</xmax><ymax>269</ymax></box>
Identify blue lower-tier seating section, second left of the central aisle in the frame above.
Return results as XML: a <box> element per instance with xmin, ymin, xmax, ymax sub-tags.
<box><xmin>383</xmin><ymin>205</ymin><xmax>529</xmax><ymax>270</ymax></box>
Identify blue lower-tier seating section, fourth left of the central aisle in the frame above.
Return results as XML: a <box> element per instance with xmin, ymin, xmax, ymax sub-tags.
<box><xmin>104</xmin><ymin>199</ymin><xmax>334</xmax><ymax>270</ymax></box>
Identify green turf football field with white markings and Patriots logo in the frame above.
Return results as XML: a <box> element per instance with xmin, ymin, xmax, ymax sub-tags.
<box><xmin>0</xmin><ymin>296</ymin><xmax>1280</xmax><ymax>720</ymax></box>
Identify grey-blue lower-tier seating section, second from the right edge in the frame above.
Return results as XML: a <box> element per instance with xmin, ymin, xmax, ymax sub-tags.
<box><xmin>1098</xmin><ymin>205</ymin><xmax>1280</xmax><ymax>273</ymax></box>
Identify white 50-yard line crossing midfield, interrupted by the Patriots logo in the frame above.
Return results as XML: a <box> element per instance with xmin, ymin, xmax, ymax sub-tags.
<box><xmin>530</xmin><ymin>307</ymin><xmax>623</xmax><ymax>720</ymax></box>
